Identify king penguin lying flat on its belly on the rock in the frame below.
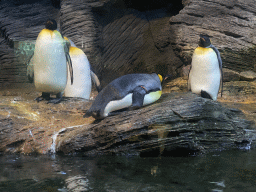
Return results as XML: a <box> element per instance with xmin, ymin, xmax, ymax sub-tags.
<box><xmin>84</xmin><ymin>73</ymin><xmax>163</xmax><ymax>119</ymax></box>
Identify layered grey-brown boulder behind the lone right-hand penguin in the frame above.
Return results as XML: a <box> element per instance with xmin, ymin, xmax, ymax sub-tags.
<box><xmin>170</xmin><ymin>0</ymin><xmax>256</xmax><ymax>72</ymax></box>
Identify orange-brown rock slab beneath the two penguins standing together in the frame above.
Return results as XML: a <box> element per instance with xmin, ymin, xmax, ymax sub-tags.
<box><xmin>0</xmin><ymin>85</ymin><xmax>93</xmax><ymax>154</ymax></box>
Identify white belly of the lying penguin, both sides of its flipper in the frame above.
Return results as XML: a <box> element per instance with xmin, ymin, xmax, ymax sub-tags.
<box><xmin>104</xmin><ymin>91</ymin><xmax>162</xmax><ymax>117</ymax></box>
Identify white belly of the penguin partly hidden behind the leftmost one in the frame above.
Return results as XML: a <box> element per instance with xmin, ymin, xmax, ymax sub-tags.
<box><xmin>64</xmin><ymin>50</ymin><xmax>92</xmax><ymax>99</ymax></box>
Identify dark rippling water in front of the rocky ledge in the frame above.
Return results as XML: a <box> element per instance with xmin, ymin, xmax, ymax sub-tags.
<box><xmin>0</xmin><ymin>149</ymin><xmax>256</xmax><ymax>192</ymax></box>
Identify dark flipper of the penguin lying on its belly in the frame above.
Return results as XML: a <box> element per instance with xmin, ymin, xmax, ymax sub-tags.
<box><xmin>130</xmin><ymin>86</ymin><xmax>147</xmax><ymax>109</ymax></box>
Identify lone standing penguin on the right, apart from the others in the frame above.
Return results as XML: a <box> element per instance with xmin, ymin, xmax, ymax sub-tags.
<box><xmin>188</xmin><ymin>34</ymin><xmax>223</xmax><ymax>101</ymax></box>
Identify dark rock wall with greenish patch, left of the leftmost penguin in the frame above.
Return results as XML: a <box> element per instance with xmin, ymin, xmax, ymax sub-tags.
<box><xmin>0</xmin><ymin>0</ymin><xmax>59</xmax><ymax>87</ymax></box>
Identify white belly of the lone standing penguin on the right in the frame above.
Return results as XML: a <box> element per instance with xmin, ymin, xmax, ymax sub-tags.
<box><xmin>189</xmin><ymin>50</ymin><xmax>221</xmax><ymax>100</ymax></box>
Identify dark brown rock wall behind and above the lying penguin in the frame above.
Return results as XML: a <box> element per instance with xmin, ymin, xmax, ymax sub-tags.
<box><xmin>61</xmin><ymin>0</ymin><xmax>182</xmax><ymax>85</ymax></box>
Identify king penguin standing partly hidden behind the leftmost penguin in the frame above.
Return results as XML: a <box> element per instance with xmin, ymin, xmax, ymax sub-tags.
<box><xmin>64</xmin><ymin>37</ymin><xmax>101</xmax><ymax>99</ymax></box>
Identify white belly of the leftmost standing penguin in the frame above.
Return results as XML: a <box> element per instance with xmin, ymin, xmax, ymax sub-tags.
<box><xmin>33</xmin><ymin>36</ymin><xmax>67</xmax><ymax>93</ymax></box>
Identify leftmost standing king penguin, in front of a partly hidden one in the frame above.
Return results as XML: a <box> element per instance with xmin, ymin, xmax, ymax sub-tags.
<box><xmin>30</xmin><ymin>19</ymin><xmax>73</xmax><ymax>103</ymax></box>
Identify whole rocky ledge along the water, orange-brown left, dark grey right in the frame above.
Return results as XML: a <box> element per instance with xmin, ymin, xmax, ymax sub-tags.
<box><xmin>0</xmin><ymin>85</ymin><xmax>255</xmax><ymax>156</ymax></box>
